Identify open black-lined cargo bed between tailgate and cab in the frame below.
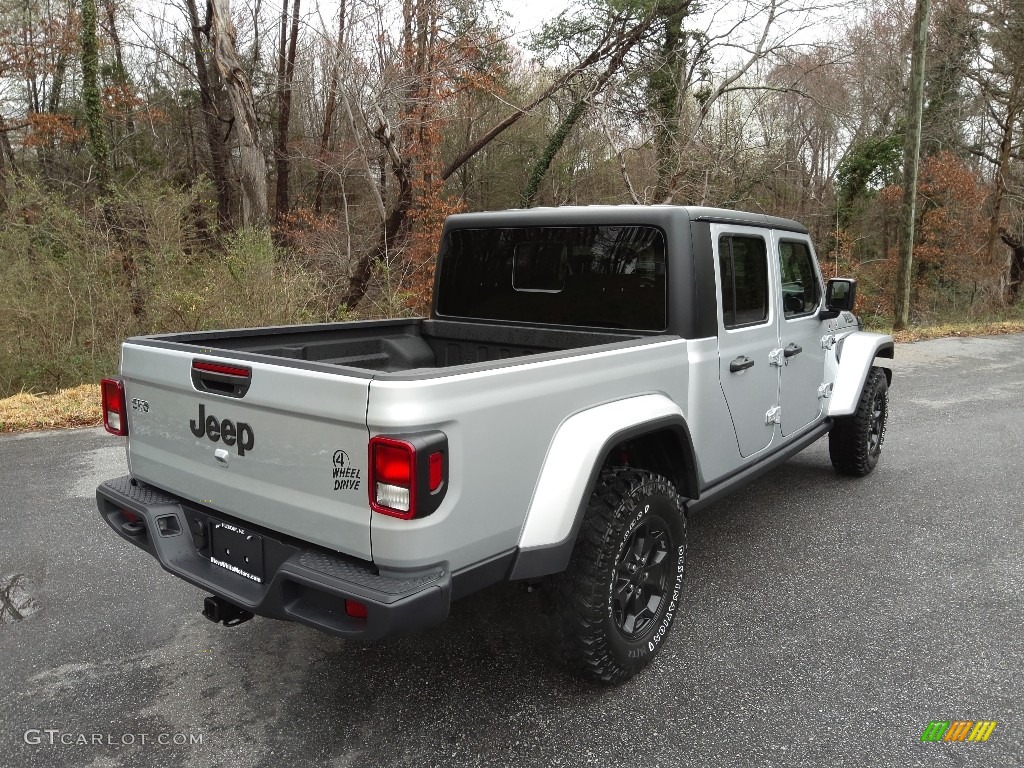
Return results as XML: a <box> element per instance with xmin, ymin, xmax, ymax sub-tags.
<box><xmin>137</xmin><ymin>318</ymin><xmax>650</xmax><ymax>373</ymax></box>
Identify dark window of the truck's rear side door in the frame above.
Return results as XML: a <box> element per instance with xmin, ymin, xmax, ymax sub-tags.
<box><xmin>718</xmin><ymin>234</ymin><xmax>768</xmax><ymax>328</ymax></box>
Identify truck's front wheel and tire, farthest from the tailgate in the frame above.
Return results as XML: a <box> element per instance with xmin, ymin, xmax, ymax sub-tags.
<box><xmin>828</xmin><ymin>367</ymin><xmax>889</xmax><ymax>477</ymax></box>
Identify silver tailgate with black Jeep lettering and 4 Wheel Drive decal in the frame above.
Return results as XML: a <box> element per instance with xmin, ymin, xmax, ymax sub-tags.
<box><xmin>121</xmin><ymin>342</ymin><xmax>371</xmax><ymax>560</ymax></box>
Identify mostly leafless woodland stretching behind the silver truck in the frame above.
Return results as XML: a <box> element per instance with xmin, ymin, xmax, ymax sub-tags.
<box><xmin>0</xmin><ymin>0</ymin><xmax>1024</xmax><ymax>397</ymax></box>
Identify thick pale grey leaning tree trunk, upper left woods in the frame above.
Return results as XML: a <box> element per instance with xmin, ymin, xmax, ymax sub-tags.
<box><xmin>208</xmin><ymin>0</ymin><xmax>267</xmax><ymax>226</ymax></box>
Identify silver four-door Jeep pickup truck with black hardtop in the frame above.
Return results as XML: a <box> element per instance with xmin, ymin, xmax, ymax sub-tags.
<box><xmin>96</xmin><ymin>206</ymin><xmax>893</xmax><ymax>682</ymax></box>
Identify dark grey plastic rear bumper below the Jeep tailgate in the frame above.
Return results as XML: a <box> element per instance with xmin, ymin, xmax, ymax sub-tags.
<box><xmin>96</xmin><ymin>476</ymin><xmax>452</xmax><ymax>640</ymax></box>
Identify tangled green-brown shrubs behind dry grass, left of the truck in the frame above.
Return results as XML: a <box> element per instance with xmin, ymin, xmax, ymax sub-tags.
<box><xmin>0</xmin><ymin>178</ymin><xmax>327</xmax><ymax>397</ymax></box>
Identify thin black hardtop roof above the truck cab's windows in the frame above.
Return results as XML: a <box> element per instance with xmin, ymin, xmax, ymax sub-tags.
<box><xmin>445</xmin><ymin>205</ymin><xmax>807</xmax><ymax>233</ymax></box>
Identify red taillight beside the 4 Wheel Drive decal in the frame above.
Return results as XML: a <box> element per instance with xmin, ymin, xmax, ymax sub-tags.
<box><xmin>369</xmin><ymin>432</ymin><xmax>447</xmax><ymax>520</ymax></box>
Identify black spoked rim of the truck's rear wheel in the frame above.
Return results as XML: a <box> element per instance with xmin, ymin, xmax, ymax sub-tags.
<box><xmin>611</xmin><ymin>517</ymin><xmax>672</xmax><ymax>640</ymax></box>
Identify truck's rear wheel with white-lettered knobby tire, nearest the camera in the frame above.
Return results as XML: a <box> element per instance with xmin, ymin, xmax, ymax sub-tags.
<box><xmin>554</xmin><ymin>468</ymin><xmax>686</xmax><ymax>683</ymax></box>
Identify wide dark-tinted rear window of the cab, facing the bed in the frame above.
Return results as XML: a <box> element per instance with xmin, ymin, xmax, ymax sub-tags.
<box><xmin>437</xmin><ymin>226</ymin><xmax>667</xmax><ymax>331</ymax></box>
